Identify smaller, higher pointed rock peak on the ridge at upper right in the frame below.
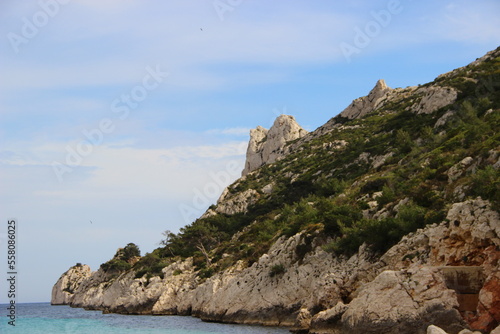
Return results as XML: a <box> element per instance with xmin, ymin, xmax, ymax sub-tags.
<box><xmin>340</xmin><ymin>79</ymin><xmax>392</xmax><ymax>119</ymax></box>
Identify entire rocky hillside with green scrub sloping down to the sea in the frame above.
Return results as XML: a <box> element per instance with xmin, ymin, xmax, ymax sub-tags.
<box><xmin>52</xmin><ymin>48</ymin><xmax>500</xmax><ymax>333</ymax></box>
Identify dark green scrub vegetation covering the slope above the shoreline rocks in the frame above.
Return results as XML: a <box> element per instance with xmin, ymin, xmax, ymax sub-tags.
<box><xmin>101</xmin><ymin>50</ymin><xmax>500</xmax><ymax>278</ymax></box>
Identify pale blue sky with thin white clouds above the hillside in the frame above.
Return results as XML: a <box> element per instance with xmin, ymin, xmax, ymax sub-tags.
<box><xmin>0</xmin><ymin>0</ymin><xmax>500</xmax><ymax>303</ymax></box>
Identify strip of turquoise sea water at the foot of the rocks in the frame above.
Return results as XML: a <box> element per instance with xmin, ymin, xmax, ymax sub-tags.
<box><xmin>0</xmin><ymin>303</ymin><xmax>289</xmax><ymax>334</ymax></box>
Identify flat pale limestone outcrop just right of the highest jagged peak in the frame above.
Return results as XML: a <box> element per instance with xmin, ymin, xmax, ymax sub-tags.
<box><xmin>412</xmin><ymin>86</ymin><xmax>457</xmax><ymax>115</ymax></box>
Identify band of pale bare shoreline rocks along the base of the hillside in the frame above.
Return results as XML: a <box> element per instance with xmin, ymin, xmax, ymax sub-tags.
<box><xmin>52</xmin><ymin>199</ymin><xmax>500</xmax><ymax>334</ymax></box>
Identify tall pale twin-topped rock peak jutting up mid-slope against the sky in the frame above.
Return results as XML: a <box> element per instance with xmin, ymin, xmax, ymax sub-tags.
<box><xmin>242</xmin><ymin>115</ymin><xmax>307</xmax><ymax>176</ymax></box>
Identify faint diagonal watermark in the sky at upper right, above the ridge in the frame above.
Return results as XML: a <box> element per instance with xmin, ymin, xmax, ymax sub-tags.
<box><xmin>340</xmin><ymin>0</ymin><xmax>411</xmax><ymax>63</ymax></box>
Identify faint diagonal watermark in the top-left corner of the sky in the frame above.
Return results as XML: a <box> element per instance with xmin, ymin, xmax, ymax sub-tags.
<box><xmin>7</xmin><ymin>0</ymin><xmax>71</xmax><ymax>54</ymax></box>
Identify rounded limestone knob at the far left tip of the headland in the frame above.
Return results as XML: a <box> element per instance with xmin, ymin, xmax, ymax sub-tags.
<box><xmin>51</xmin><ymin>264</ymin><xmax>91</xmax><ymax>305</ymax></box>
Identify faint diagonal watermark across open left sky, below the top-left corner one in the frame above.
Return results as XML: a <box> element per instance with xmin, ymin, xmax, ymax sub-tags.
<box><xmin>51</xmin><ymin>65</ymin><xmax>169</xmax><ymax>183</ymax></box>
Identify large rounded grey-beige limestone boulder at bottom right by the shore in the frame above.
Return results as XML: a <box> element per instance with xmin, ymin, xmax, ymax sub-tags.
<box><xmin>342</xmin><ymin>267</ymin><xmax>464</xmax><ymax>334</ymax></box>
